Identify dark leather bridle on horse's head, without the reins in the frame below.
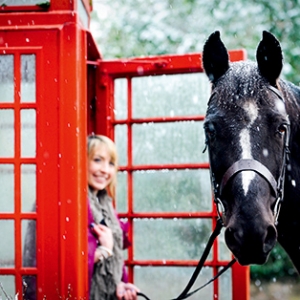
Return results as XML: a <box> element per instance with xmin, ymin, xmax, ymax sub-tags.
<box><xmin>204</xmin><ymin>86</ymin><xmax>290</xmax><ymax>225</ymax></box>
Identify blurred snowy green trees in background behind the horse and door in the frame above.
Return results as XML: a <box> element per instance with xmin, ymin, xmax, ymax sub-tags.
<box><xmin>91</xmin><ymin>0</ymin><xmax>300</xmax><ymax>280</ymax></box>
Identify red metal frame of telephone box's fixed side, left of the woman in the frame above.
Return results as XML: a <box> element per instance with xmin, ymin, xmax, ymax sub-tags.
<box><xmin>0</xmin><ymin>1</ymin><xmax>90</xmax><ymax>299</ymax></box>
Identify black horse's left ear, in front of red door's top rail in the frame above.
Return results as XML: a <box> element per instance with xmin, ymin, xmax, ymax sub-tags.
<box><xmin>202</xmin><ymin>31</ymin><xmax>229</xmax><ymax>83</ymax></box>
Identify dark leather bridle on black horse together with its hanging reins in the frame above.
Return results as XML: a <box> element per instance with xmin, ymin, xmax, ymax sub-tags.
<box><xmin>137</xmin><ymin>86</ymin><xmax>290</xmax><ymax>300</ymax></box>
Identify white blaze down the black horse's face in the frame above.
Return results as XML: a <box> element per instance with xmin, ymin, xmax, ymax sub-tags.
<box><xmin>240</xmin><ymin>101</ymin><xmax>258</xmax><ymax>196</ymax></box>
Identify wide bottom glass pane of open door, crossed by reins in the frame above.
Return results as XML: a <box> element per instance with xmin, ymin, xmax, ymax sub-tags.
<box><xmin>134</xmin><ymin>266</ymin><xmax>212</xmax><ymax>300</ymax></box>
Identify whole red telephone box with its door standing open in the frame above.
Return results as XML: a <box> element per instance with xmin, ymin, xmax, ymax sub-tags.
<box><xmin>0</xmin><ymin>0</ymin><xmax>249</xmax><ymax>300</ymax></box>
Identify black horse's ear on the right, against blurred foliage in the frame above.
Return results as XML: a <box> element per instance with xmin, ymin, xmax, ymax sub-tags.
<box><xmin>256</xmin><ymin>31</ymin><xmax>283</xmax><ymax>86</ymax></box>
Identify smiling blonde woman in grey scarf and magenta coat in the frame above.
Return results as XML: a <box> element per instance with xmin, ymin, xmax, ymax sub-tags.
<box><xmin>88</xmin><ymin>135</ymin><xmax>139</xmax><ymax>300</ymax></box>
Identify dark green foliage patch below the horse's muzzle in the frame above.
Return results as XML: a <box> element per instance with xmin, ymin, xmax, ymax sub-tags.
<box><xmin>250</xmin><ymin>244</ymin><xmax>298</xmax><ymax>281</ymax></box>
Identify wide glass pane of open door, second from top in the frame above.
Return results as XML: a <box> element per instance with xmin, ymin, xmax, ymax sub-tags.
<box><xmin>132</xmin><ymin>122</ymin><xmax>208</xmax><ymax>165</ymax></box>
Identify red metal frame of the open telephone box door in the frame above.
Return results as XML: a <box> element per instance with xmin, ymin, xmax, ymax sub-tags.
<box><xmin>94</xmin><ymin>50</ymin><xmax>250</xmax><ymax>299</ymax></box>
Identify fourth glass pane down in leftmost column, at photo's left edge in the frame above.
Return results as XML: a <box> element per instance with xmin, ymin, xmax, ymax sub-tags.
<box><xmin>0</xmin><ymin>220</ymin><xmax>15</xmax><ymax>268</ymax></box>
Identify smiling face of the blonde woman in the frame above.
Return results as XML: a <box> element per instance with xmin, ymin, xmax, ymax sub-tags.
<box><xmin>88</xmin><ymin>144</ymin><xmax>116</xmax><ymax>193</ymax></box>
